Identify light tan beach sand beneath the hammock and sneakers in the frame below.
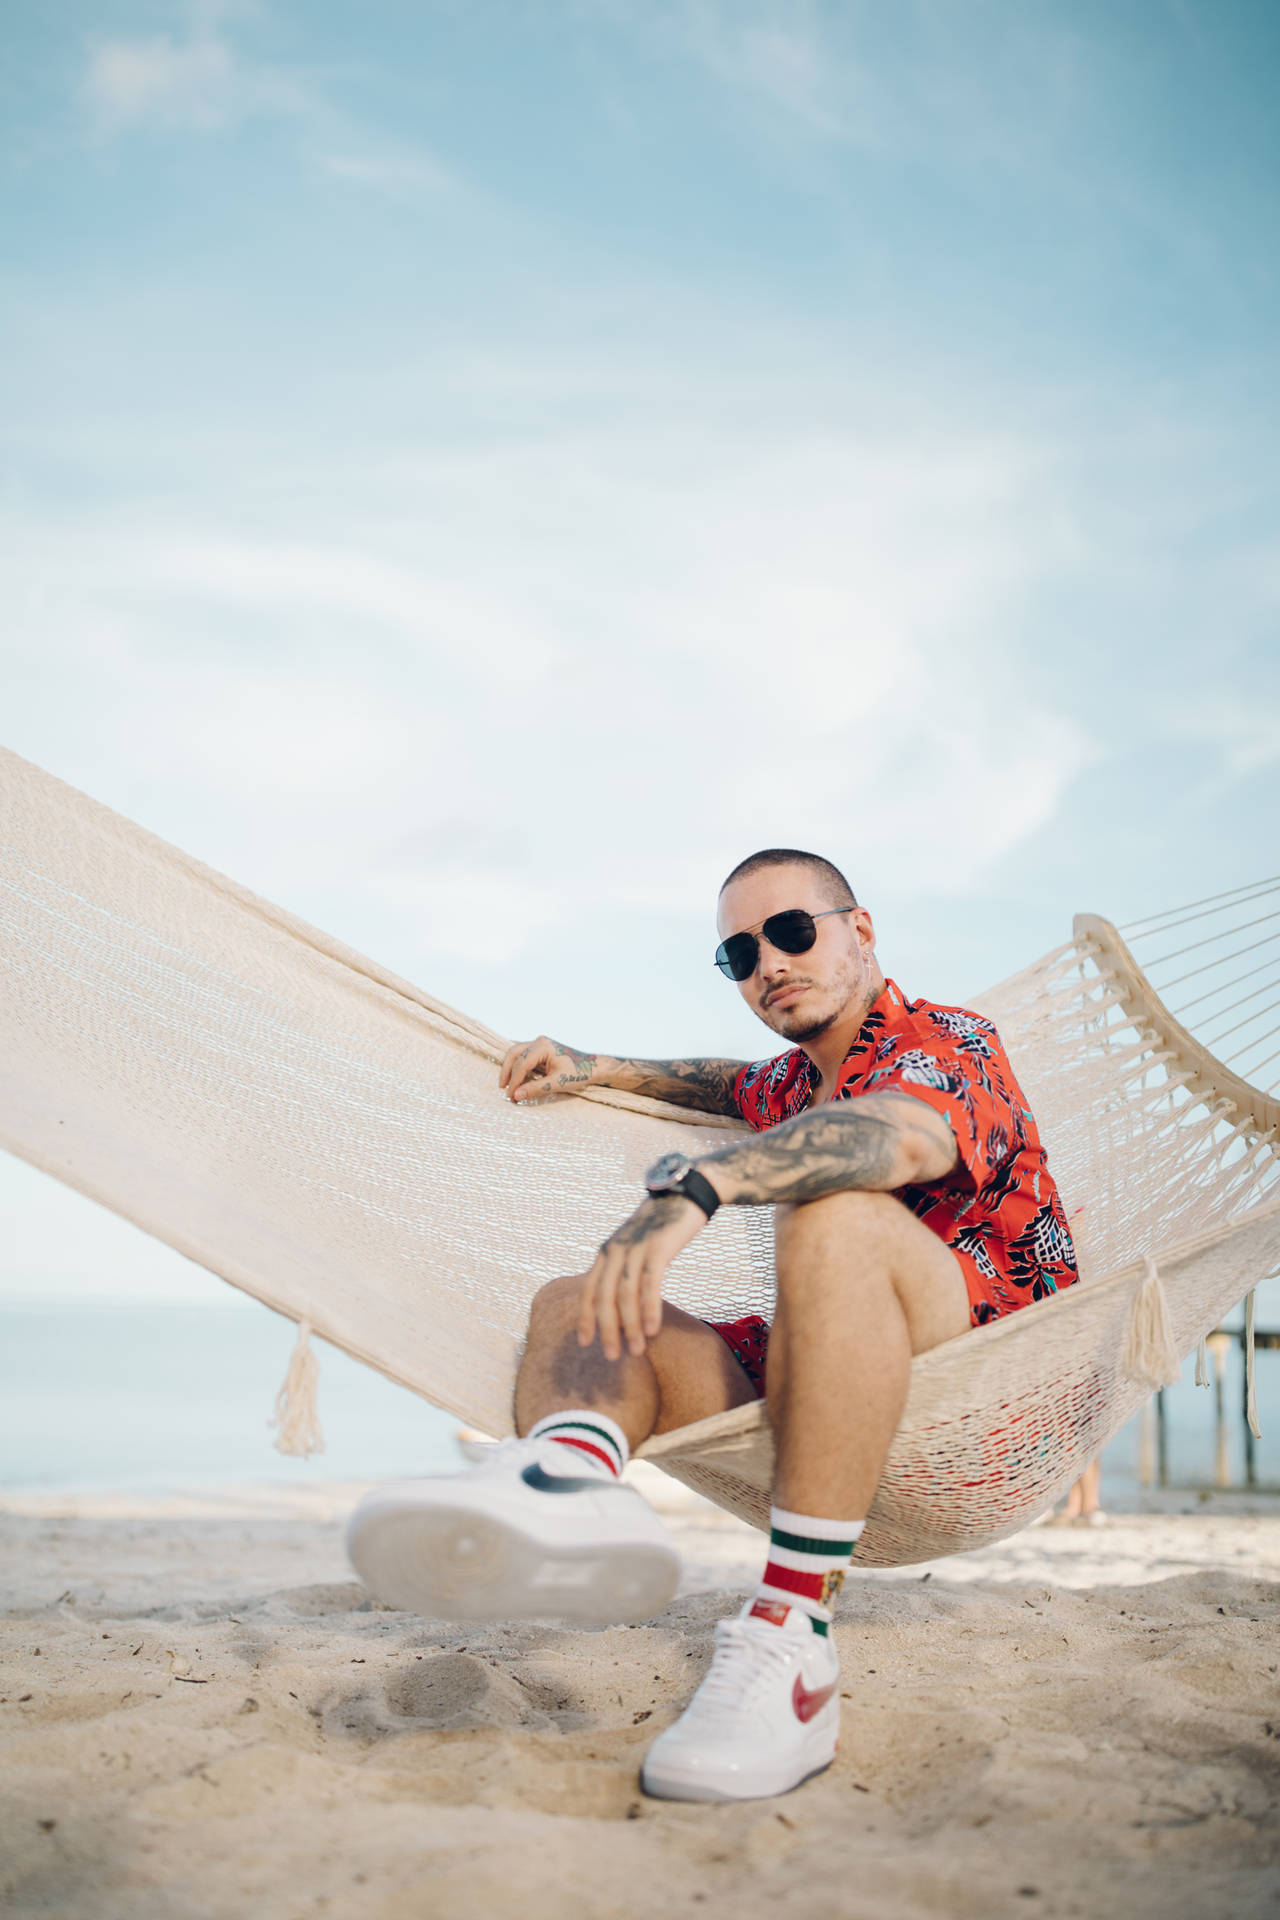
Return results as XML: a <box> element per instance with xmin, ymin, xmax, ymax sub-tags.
<box><xmin>0</xmin><ymin>1469</ymin><xmax>1280</xmax><ymax>1920</ymax></box>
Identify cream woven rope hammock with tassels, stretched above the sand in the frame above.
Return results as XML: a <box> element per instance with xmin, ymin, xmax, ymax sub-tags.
<box><xmin>0</xmin><ymin>751</ymin><xmax>1280</xmax><ymax>1567</ymax></box>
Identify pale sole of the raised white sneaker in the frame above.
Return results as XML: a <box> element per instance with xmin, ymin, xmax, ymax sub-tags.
<box><xmin>339</xmin><ymin>1488</ymin><xmax>679</xmax><ymax>1626</ymax></box>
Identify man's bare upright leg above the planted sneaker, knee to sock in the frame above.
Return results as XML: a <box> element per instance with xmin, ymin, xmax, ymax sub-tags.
<box><xmin>768</xmin><ymin>1192</ymin><xmax>969</xmax><ymax>1521</ymax></box>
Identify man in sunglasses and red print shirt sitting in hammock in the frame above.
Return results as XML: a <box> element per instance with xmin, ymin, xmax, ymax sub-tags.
<box><xmin>349</xmin><ymin>847</ymin><xmax>1075</xmax><ymax>1799</ymax></box>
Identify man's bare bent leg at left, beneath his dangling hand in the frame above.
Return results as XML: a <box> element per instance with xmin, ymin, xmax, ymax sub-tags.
<box><xmin>516</xmin><ymin>1275</ymin><xmax>756</xmax><ymax>1448</ymax></box>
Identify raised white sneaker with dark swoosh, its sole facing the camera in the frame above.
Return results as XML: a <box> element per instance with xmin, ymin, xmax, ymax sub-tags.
<box><xmin>339</xmin><ymin>1440</ymin><xmax>679</xmax><ymax>1626</ymax></box>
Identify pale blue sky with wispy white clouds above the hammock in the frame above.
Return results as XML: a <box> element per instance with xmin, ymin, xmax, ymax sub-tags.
<box><xmin>0</xmin><ymin>0</ymin><xmax>1280</xmax><ymax>1294</ymax></box>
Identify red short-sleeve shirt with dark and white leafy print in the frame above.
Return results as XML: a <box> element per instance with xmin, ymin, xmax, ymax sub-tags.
<box><xmin>733</xmin><ymin>981</ymin><xmax>1077</xmax><ymax>1327</ymax></box>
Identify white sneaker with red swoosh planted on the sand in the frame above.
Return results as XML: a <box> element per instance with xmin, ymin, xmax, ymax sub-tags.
<box><xmin>641</xmin><ymin>1599</ymin><xmax>841</xmax><ymax>1801</ymax></box>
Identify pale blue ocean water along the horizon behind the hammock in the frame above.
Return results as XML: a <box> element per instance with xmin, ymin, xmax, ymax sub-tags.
<box><xmin>0</xmin><ymin>1283</ymin><xmax>1280</xmax><ymax>1501</ymax></box>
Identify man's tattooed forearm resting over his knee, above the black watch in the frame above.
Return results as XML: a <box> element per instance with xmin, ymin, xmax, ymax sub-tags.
<box><xmin>699</xmin><ymin>1094</ymin><xmax>956</xmax><ymax>1206</ymax></box>
